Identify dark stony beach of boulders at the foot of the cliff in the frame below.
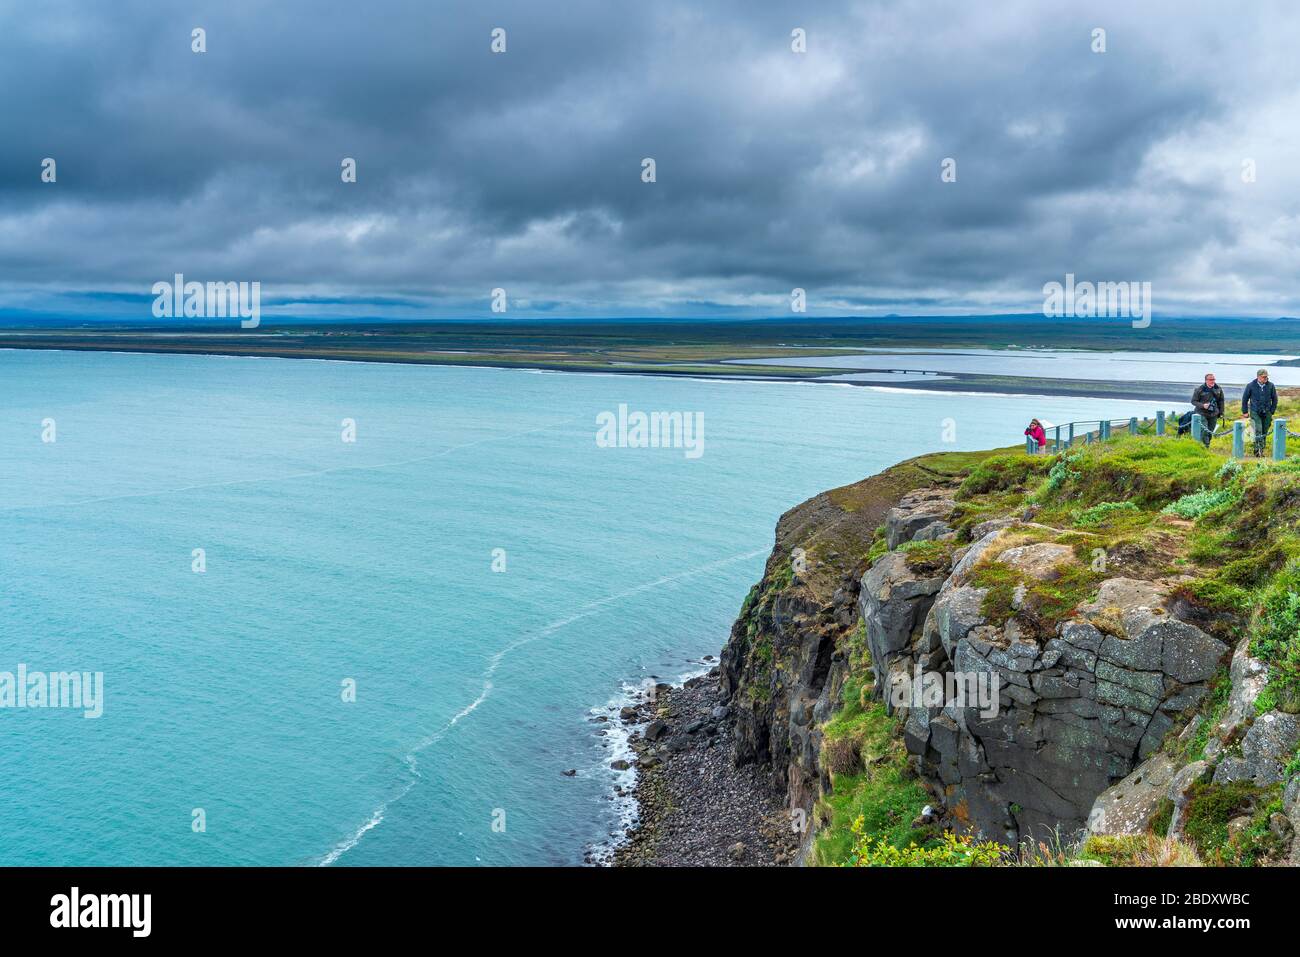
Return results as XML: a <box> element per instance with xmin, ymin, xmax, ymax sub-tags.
<box><xmin>612</xmin><ymin>667</ymin><xmax>800</xmax><ymax>867</ymax></box>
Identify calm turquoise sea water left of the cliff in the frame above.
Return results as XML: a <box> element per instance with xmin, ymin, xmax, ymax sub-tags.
<box><xmin>0</xmin><ymin>351</ymin><xmax>1153</xmax><ymax>865</ymax></box>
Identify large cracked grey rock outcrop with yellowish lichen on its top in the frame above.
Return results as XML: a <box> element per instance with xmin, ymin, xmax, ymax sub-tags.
<box><xmin>859</xmin><ymin>498</ymin><xmax>1229</xmax><ymax>846</ymax></box>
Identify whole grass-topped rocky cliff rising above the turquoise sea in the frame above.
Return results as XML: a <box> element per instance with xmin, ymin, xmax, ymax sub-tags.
<box><xmin>720</xmin><ymin>441</ymin><xmax>1300</xmax><ymax>863</ymax></box>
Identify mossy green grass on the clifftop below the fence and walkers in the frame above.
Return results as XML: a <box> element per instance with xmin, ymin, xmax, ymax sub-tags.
<box><xmin>954</xmin><ymin>399</ymin><xmax>1300</xmax><ymax>713</ymax></box>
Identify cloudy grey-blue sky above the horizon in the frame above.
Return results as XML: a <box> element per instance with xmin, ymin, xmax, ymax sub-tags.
<box><xmin>0</xmin><ymin>0</ymin><xmax>1300</xmax><ymax>321</ymax></box>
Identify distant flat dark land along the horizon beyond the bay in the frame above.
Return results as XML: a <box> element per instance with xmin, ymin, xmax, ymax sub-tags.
<box><xmin>0</xmin><ymin>316</ymin><xmax>1300</xmax><ymax>400</ymax></box>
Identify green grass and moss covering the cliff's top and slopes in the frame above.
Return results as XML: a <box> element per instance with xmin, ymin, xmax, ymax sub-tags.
<box><xmin>770</xmin><ymin>394</ymin><xmax>1300</xmax><ymax>865</ymax></box>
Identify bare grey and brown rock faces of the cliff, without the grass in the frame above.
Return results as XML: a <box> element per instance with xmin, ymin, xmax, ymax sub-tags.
<box><xmin>722</xmin><ymin>460</ymin><xmax>1300</xmax><ymax>859</ymax></box>
